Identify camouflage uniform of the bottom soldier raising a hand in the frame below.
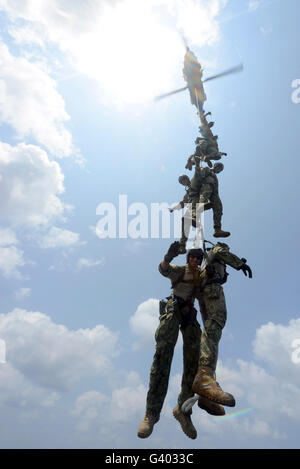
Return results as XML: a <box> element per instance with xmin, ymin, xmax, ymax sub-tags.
<box><xmin>146</xmin><ymin>265</ymin><xmax>201</xmax><ymax>418</ymax></box>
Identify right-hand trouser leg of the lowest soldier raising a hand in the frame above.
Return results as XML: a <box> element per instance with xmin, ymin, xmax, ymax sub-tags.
<box><xmin>178</xmin><ymin>318</ymin><xmax>201</xmax><ymax>407</ymax></box>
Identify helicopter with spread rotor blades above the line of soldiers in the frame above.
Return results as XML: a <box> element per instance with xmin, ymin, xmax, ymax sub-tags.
<box><xmin>154</xmin><ymin>45</ymin><xmax>244</xmax><ymax>114</ymax></box>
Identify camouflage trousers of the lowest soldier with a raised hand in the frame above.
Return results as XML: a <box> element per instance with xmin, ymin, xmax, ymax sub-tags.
<box><xmin>146</xmin><ymin>300</ymin><xmax>201</xmax><ymax>418</ymax></box>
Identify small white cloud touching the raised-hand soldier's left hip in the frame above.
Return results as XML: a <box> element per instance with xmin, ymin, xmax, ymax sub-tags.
<box><xmin>129</xmin><ymin>298</ymin><xmax>159</xmax><ymax>350</ymax></box>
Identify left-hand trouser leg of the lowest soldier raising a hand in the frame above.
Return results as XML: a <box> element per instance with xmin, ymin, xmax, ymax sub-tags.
<box><xmin>146</xmin><ymin>300</ymin><xmax>179</xmax><ymax>419</ymax></box>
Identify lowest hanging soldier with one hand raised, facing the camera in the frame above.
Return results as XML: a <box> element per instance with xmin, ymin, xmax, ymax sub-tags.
<box><xmin>138</xmin><ymin>241</ymin><xmax>222</xmax><ymax>439</ymax></box>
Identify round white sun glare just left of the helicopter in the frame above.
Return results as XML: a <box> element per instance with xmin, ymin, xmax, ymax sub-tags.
<box><xmin>72</xmin><ymin>0</ymin><xmax>183</xmax><ymax>103</ymax></box>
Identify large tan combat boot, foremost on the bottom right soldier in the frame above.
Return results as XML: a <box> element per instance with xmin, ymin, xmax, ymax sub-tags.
<box><xmin>192</xmin><ymin>366</ymin><xmax>235</xmax><ymax>407</ymax></box>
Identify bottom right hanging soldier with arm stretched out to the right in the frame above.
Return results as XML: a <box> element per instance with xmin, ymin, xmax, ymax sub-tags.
<box><xmin>192</xmin><ymin>243</ymin><xmax>252</xmax><ymax>407</ymax></box>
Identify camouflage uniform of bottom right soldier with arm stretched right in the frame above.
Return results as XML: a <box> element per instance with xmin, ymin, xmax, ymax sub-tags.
<box><xmin>196</xmin><ymin>243</ymin><xmax>244</xmax><ymax>370</ymax></box>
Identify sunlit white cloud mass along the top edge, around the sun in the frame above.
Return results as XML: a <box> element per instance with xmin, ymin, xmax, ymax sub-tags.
<box><xmin>0</xmin><ymin>0</ymin><xmax>227</xmax><ymax>105</ymax></box>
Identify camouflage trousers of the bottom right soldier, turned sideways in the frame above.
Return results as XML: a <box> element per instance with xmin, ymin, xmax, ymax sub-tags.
<box><xmin>198</xmin><ymin>283</ymin><xmax>227</xmax><ymax>370</ymax></box>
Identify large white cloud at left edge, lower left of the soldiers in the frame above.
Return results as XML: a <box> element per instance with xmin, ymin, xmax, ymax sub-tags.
<box><xmin>0</xmin><ymin>309</ymin><xmax>118</xmax><ymax>394</ymax></box>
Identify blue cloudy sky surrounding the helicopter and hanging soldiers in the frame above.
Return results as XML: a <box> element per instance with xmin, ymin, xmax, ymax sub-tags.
<box><xmin>0</xmin><ymin>0</ymin><xmax>300</xmax><ymax>448</ymax></box>
